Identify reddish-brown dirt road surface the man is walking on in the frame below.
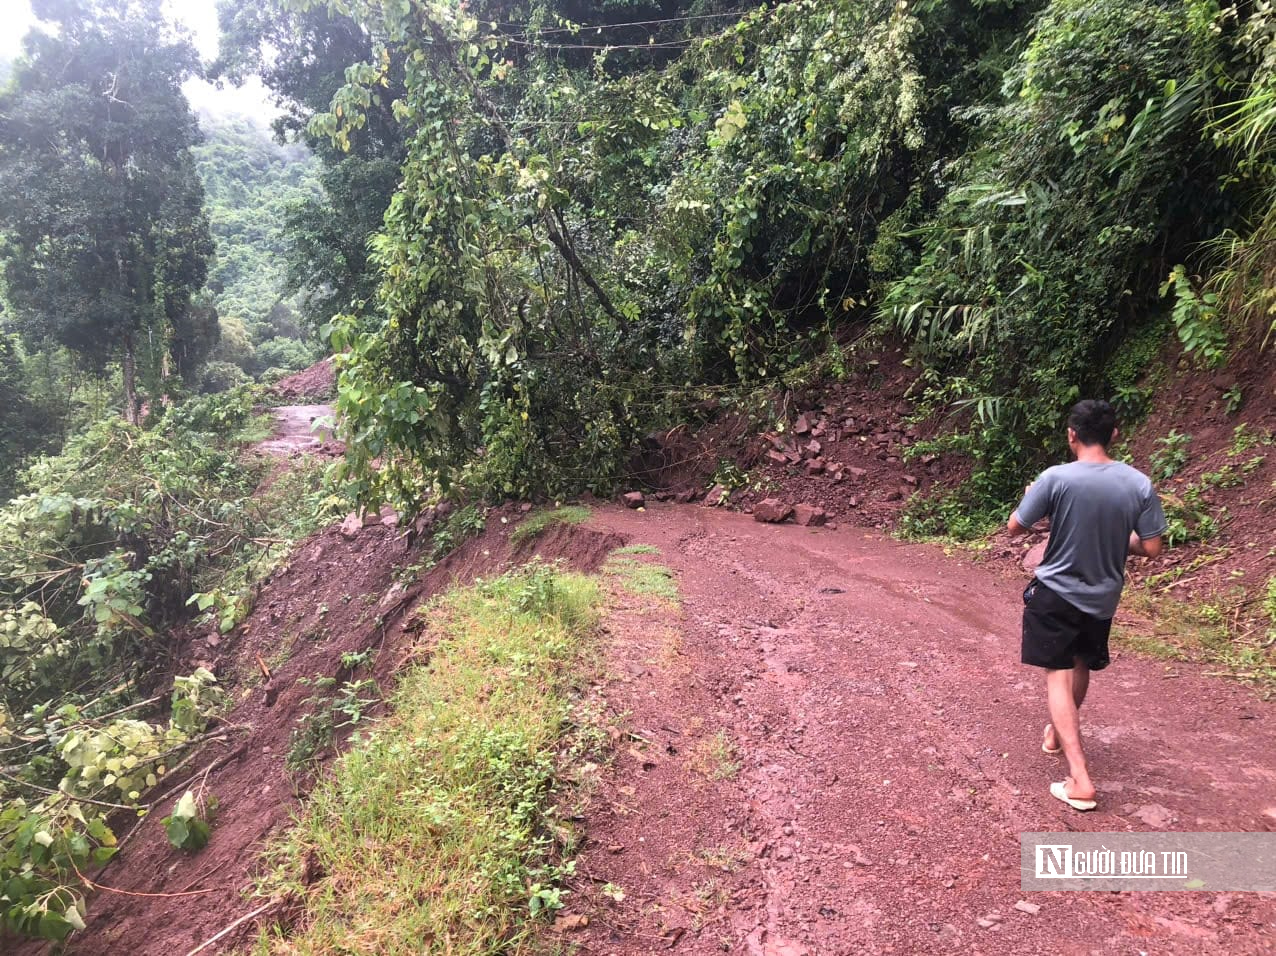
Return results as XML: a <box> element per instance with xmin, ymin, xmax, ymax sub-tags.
<box><xmin>565</xmin><ymin>505</ymin><xmax>1276</xmax><ymax>956</ymax></box>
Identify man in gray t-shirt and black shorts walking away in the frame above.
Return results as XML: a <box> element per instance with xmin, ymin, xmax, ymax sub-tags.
<box><xmin>1008</xmin><ymin>400</ymin><xmax>1165</xmax><ymax>810</ymax></box>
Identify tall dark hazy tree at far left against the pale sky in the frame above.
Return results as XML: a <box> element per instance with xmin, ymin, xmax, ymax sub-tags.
<box><xmin>0</xmin><ymin>0</ymin><xmax>216</xmax><ymax>424</ymax></box>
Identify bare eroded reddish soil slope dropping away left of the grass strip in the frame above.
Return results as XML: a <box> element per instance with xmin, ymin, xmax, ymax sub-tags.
<box><xmin>39</xmin><ymin>507</ymin><xmax>624</xmax><ymax>956</ymax></box>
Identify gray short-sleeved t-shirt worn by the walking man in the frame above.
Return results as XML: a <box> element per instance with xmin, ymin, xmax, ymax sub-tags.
<box><xmin>1014</xmin><ymin>462</ymin><xmax>1165</xmax><ymax>620</ymax></box>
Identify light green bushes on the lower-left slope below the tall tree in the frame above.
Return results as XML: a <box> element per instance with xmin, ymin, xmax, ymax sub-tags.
<box><xmin>0</xmin><ymin>389</ymin><xmax>334</xmax><ymax>938</ymax></box>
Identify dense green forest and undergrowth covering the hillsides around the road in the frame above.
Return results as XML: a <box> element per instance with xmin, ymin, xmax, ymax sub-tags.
<box><xmin>0</xmin><ymin>0</ymin><xmax>1276</xmax><ymax>938</ymax></box>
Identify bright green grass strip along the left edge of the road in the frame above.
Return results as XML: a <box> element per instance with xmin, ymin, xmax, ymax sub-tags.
<box><xmin>255</xmin><ymin>564</ymin><xmax>601</xmax><ymax>955</ymax></box>
